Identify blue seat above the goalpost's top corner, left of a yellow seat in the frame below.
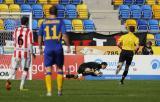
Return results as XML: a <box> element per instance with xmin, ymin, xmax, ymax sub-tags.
<box><xmin>32</xmin><ymin>4</ymin><xmax>43</xmax><ymax>18</ymax></box>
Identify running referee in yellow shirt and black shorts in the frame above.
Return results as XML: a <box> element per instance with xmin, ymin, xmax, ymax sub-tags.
<box><xmin>116</xmin><ymin>26</ymin><xmax>139</xmax><ymax>84</ymax></box>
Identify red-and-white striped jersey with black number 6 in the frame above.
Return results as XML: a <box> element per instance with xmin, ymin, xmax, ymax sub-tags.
<box><xmin>13</xmin><ymin>25</ymin><xmax>33</xmax><ymax>59</ymax></box>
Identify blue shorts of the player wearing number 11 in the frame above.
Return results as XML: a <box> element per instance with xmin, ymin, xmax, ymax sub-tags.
<box><xmin>44</xmin><ymin>49</ymin><xmax>64</xmax><ymax>68</ymax></box>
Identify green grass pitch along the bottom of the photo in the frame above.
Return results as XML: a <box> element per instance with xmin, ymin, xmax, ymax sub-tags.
<box><xmin>0</xmin><ymin>80</ymin><xmax>160</xmax><ymax>102</ymax></box>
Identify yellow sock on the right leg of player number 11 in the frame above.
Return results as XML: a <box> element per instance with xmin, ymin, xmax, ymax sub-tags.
<box><xmin>57</xmin><ymin>71</ymin><xmax>63</xmax><ymax>91</ymax></box>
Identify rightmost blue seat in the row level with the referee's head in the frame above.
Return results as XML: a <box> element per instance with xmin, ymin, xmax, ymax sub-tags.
<box><xmin>148</xmin><ymin>19</ymin><xmax>159</xmax><ymax>33</ymax></box>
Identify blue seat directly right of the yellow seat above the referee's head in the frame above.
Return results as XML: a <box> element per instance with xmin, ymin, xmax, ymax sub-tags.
<box><xmin>137</xmin><ymin>19</ymin><xmax>148</xmax><ymax>31</ymax></box>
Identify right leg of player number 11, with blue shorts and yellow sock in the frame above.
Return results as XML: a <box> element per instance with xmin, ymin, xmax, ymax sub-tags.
<box><xmin>56</xmin><ymin>49</ymin><xmax>64</xmax><ymax>96</ymax></box>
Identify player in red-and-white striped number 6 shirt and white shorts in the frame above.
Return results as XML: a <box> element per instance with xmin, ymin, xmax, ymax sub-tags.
<box><xmin>6</xmin><ymin>17</ymin><xmax>35</xmax><ymax>91</ymax></box>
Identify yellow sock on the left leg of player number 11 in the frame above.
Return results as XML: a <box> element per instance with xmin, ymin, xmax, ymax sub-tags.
<box><xmin>45</xmin><ymin>69</ymin><xmax>52</xmax><ymax>93</ymax></box>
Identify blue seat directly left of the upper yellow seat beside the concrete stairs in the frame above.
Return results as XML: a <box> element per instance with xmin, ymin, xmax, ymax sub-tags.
<box><xmin>66</xmin><ymin>4</ymin><xmax>77</xmax><ymax>19</ymax></box>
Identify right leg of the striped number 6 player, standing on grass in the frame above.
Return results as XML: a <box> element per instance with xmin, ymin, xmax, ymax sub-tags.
<box><xmin>19</xmin><ymin>58</ymin><xmax>31</xmax><ymax>91</ymax></box>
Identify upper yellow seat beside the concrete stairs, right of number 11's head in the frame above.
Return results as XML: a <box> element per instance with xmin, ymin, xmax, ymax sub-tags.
<box><xmin>77</xmin><ymin>4</ymin><xmax>88</xmax><ymax>19</ymax></box>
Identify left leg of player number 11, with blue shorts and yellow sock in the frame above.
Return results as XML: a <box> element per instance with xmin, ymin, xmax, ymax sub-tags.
<box><xmin>44</xmin><ymin>52</ymin><xmax>54</xmax><ymax>96</ymax></box>
